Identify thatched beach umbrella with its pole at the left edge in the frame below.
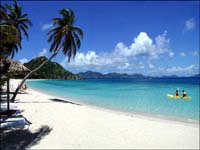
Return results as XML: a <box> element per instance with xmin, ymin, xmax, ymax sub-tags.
<box><xmin>0</xmin><ymin>58</ymin><xmax>30</xmax><ymax>116</ymax></box>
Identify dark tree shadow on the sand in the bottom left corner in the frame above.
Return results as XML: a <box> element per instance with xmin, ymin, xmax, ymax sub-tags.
<box><xmin>0</xmin><ymin>126</ymin><xmax>52</xmax><ymax>150</ymax></box>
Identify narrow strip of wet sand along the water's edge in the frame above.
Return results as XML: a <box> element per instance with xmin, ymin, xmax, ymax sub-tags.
<box><xmin>28</xmin><ymin>79</ymin><xmax>199</xmax><ymax>128</ymax></box>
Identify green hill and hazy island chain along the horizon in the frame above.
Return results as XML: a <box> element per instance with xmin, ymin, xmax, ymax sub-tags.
<box><xmin>16</xmin><ymin>56</ymin><xmax>200</xmax><ymax>80</ymax></box>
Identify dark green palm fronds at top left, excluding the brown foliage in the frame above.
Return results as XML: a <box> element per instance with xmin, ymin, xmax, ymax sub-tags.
<box><xmin>0</xmin><ymin>0</ymin><xmax>32</xmax><ymax>58</ymax></box>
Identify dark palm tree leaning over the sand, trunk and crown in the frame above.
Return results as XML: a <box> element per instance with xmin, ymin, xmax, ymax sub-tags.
<box><xmin>12</xmin><ymin>9</ymin><xmax>83</xmax><ymax>101</ymax></box>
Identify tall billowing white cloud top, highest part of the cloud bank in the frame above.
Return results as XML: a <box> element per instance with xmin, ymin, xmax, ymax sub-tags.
<box><xmin>115</xmin><ymin>31</ymin><xmax>170</xmax><ymax>58</ymax></box>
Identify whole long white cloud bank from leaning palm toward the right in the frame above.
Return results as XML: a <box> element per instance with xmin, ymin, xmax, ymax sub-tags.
<box><xmin>61</xmin><ymin>31</ymin><xmax>178</xmax><ymax>73</ymax></box>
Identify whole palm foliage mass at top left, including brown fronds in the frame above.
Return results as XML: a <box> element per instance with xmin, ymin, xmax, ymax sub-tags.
<box><xmin>0</xmin><ymin>1</ymin><xmax>32</xmax><ymax>58</ymax></box>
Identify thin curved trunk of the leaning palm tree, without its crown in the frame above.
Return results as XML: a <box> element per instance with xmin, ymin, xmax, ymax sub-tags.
<box><xmin>11</xmin><ymin>48</ymin><xmax>60</xmax><ymax>102</ymax></box>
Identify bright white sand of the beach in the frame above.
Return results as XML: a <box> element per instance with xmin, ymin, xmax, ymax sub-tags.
<box><xmin>1</xmin><ymin>80</ymin><xmax>199</xmax><ymax>149</ymax></box>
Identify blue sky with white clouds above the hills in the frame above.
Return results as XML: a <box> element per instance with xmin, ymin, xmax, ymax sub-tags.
<box><xmin>3</xmin><ymin>1</ymin><xmax>200</xmax><ymax>76</ymax></box>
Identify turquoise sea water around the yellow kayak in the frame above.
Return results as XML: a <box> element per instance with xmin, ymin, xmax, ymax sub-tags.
<box><xmin>28</xmin><ymin>78</ymin><xmax>199</xmax><ymax>120</ymax></box>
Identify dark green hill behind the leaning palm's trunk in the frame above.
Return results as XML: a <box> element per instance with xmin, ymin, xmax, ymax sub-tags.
<box><xmin>24</xmin><ymin>56</ymin><xmax>80</xmax><ymax>80</ymax></box>
